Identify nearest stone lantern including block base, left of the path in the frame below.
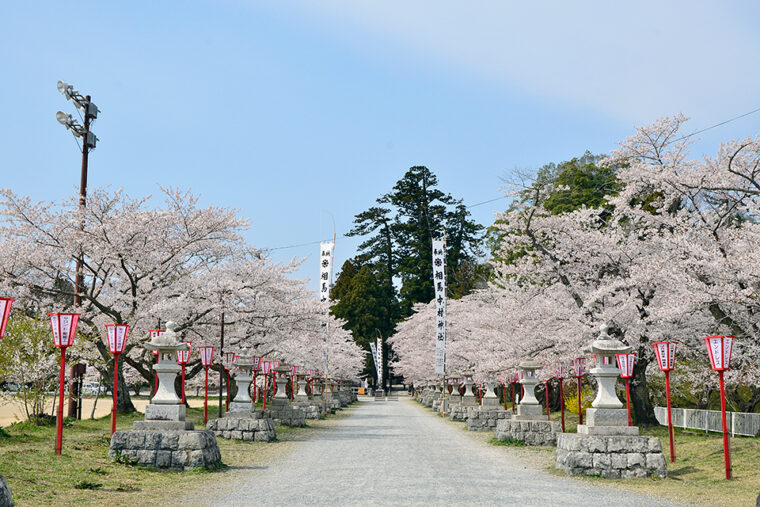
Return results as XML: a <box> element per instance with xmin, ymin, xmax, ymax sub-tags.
<box><xmin>108</xmin><ymin>322</ymin><xmax>222</xmax><ymax>470</ymax></box>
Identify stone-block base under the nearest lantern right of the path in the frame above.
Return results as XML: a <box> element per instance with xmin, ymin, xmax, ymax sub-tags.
<box><xmin>555</xmin><ymin>433</ymin><xmax>668</xmax><ymax>479</ymax></box>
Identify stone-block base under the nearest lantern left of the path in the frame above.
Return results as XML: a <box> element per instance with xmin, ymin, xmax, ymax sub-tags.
<box><xmin>108</xmin><ymin>430</ymin><xmax>222</xmax><ymax>470</ymax></box>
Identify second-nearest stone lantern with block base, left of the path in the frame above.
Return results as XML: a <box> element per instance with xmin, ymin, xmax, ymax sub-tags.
<box><xmin>206</xmin><ymin>349</ymin><xmax>277</xmax><ymax>442</ymax></box>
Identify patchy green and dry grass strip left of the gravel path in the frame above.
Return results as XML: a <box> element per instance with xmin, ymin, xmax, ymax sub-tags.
<box><xmin>0</xmin><ymin>400</ymin><xmax>352</xmax><ymax>506</ymax></box>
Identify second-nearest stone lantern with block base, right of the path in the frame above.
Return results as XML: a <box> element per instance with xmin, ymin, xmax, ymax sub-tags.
<box><xmin>496</xmin><ymin>359</ymin><xmax>562</xmax><ymax>445</ymax></box>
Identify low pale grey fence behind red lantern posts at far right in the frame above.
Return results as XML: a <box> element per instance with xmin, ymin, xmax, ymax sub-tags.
<box><xmin>654</xmin><ymin>407</ymin><xmax>760</xmax><ymax>437</ymax></box>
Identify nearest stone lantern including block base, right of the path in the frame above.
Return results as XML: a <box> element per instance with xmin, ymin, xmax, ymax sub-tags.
<box><xmin>555</xmin><ymin>324</ymin><xmax>667</xmax><ymax>479</ymax></box>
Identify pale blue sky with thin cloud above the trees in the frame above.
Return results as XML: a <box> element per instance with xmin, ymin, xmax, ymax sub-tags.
<box><xmin>0</xmin><ymin>0</ymin><xmax>760</xmax><ymax>288</ymax></box>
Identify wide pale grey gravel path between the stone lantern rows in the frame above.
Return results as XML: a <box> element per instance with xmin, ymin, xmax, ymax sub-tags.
<box><xmin>193</xmin><ymin>397</ymin><xmax>684</xmax><ymax>507</ymax></box>
